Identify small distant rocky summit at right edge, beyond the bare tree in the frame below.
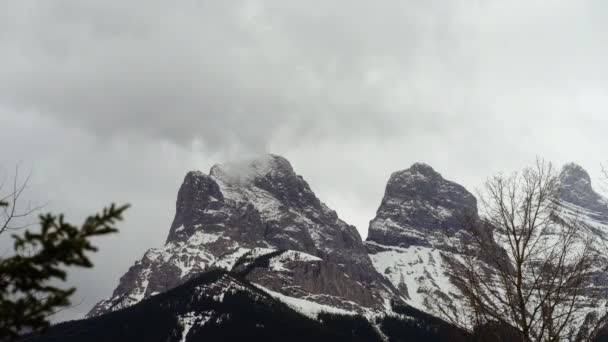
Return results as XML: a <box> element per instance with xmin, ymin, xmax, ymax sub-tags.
<box><xmin>559</xmin><ymin>163</ymin><xmax>608</xmax><ymax>216</ymax></box>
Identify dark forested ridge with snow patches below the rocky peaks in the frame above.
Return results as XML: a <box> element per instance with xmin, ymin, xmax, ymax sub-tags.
<box><xmin>27</xmin><ymin>270</ymin><xmax>470</xmax><ymax>342</ymax></box>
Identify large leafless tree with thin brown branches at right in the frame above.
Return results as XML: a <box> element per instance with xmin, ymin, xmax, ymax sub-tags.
<box><xmin>432</xmin><ymin>161</ymin><xmax>606</xmax><ymax>342</ymax></box>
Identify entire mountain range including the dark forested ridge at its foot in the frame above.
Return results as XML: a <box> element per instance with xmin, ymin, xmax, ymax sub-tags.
<box><xmin>36</xmin><ymin>155</ymin><xmax>608</xmax><ymax>342</ymax></box>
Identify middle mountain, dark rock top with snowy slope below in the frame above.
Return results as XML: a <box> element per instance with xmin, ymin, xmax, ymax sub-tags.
<box><xmin>366</xmin><ymin>163</ymin><xmax>478</xmax><ymax>310</ymax></box>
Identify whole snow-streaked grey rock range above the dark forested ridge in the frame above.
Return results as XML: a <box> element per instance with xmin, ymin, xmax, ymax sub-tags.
<box><xmin>88</xmin><ymin>155</ymin><xmax>608</xmax><ymax>330</ymax></box>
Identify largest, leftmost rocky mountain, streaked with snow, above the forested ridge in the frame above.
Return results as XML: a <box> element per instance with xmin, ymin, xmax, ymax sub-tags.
<box><xmin>89</xmin><ymin>155</ymin><xmax>396</xmax><ymax>316</ymax></box>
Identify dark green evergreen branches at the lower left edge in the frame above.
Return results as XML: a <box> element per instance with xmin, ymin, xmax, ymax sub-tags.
<box><xmin>0</xmin><ymin>201</ymin><xmax>128</xmax><ymax>341</ymax></box>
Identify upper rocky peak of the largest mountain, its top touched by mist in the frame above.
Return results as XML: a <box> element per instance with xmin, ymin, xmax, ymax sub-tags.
<box><xmin>168</xmin><ymin>155</ymin><xmax>356</xmax><ymax>255</ymax></box>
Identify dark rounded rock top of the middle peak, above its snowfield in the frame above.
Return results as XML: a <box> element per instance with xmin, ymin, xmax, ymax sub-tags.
<box><xmin>368</xmin><ymin>163</ymin><xmax>477</xmax><ymax>246</ymax></box>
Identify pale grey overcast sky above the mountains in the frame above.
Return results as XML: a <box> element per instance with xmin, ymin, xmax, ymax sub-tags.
<box><xmin>0</xmin><ymin>0</ymin><xmax>608</xmax><ymax>319</ymax></box>
